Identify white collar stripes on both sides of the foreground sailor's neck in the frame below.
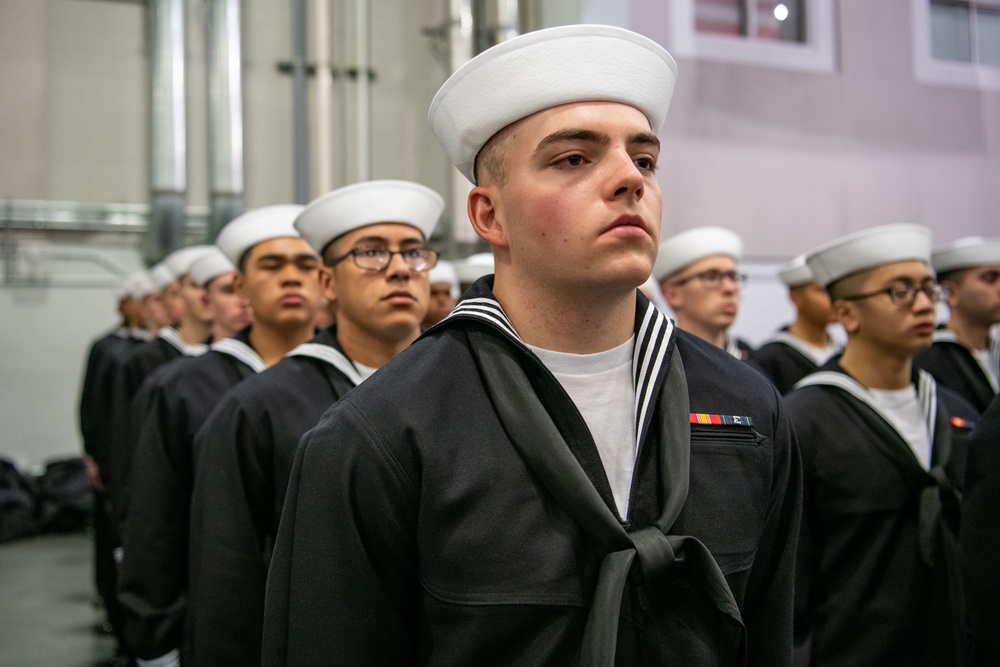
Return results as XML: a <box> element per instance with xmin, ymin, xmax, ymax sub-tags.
<box><xmin>448</xmin><ymin>297</ymin><xmax>674</xmax><ymax>454</ymax></box>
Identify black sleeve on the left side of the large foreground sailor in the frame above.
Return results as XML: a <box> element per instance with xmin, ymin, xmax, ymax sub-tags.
<box><xmin>263</xmin><ymin>399</ymin><xmax>420</xmax><ymax>667</ymax></box>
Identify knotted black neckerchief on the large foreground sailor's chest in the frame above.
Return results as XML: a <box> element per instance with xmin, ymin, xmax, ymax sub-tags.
<box><xmin>468</xmin><ymin>327</ymin><xmax>746</xmax><ymax>667</ymax></box>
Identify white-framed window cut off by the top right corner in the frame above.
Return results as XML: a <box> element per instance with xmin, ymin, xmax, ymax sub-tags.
<box><xmin>913</xmin><ymin>0</ymin><xmax>1000</xmax><ymax>90</ymax></box>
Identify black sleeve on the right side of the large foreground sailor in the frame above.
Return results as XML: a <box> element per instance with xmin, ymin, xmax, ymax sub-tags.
<box><xmin>743</xmin><ymin>394</ymin><xmax>802</xmax><ymax>667</ymax></box>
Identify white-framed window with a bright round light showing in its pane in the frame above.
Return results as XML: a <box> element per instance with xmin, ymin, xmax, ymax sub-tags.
<box><xmin>670</xmin><ymin>0</ymin><xmax>836</xmax><ymax>72</ymax></box>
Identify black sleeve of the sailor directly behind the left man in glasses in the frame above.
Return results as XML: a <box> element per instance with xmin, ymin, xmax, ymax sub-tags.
<box><xmin>119</xmin><ymin>380</ymin><xmax>191</xmax><ymax>660</ymax></box>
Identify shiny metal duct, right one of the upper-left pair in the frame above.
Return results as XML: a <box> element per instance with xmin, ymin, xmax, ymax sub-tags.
<box><xmin>206</xmin><ymin>0</ymin><xmax>244</xmax><ymax>243</ymax></box>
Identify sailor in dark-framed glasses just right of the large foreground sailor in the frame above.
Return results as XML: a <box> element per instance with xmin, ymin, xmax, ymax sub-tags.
<box><xmin>785</xmin><ymin>224</ymin><xmax>977</xmax><ymax>667</ymax></box>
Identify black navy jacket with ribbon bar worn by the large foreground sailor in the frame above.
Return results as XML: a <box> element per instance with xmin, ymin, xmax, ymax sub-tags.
<box><xmin>263</xmin><ymin>277</ymin><xmax>801</xmax><ymax>666</ymax></box>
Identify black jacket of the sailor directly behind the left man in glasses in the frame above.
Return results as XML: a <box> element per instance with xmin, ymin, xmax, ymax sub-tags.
<box><xmin>118</xmin><ymin>328</ymin><xmax>264</xmax><ymax>659</ymax></box>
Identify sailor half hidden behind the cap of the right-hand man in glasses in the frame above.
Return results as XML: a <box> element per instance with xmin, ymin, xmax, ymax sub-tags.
<box><xmin>750</xmin><ymin>255</ymin><xmax>840</xmax><ymax>394</ymax></box>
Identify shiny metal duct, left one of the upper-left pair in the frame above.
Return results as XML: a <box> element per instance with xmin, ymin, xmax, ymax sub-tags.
<box><xmin>142</xmin><ymin>0</ymin><xmax>187</xmax><ymax>264</ymax></box>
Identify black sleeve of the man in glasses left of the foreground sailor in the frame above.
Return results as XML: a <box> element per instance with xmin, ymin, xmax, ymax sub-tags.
<box><xmin>188</xmin><ymin>393</ymin><xmax>274</xmax><ymax>665</ymax></box>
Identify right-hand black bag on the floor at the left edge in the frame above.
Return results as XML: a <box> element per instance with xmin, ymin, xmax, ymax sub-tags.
<box><xmin>36</xmin><ymin>457</ymin><xmax>94</xmax><ymax>533</ymax></box>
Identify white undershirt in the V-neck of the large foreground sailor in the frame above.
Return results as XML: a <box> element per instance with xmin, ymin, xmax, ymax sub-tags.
<box><xmin>528</xmin><ymin>338</ymin><xmax>636</xmax><ymax>518</ymax></box>
